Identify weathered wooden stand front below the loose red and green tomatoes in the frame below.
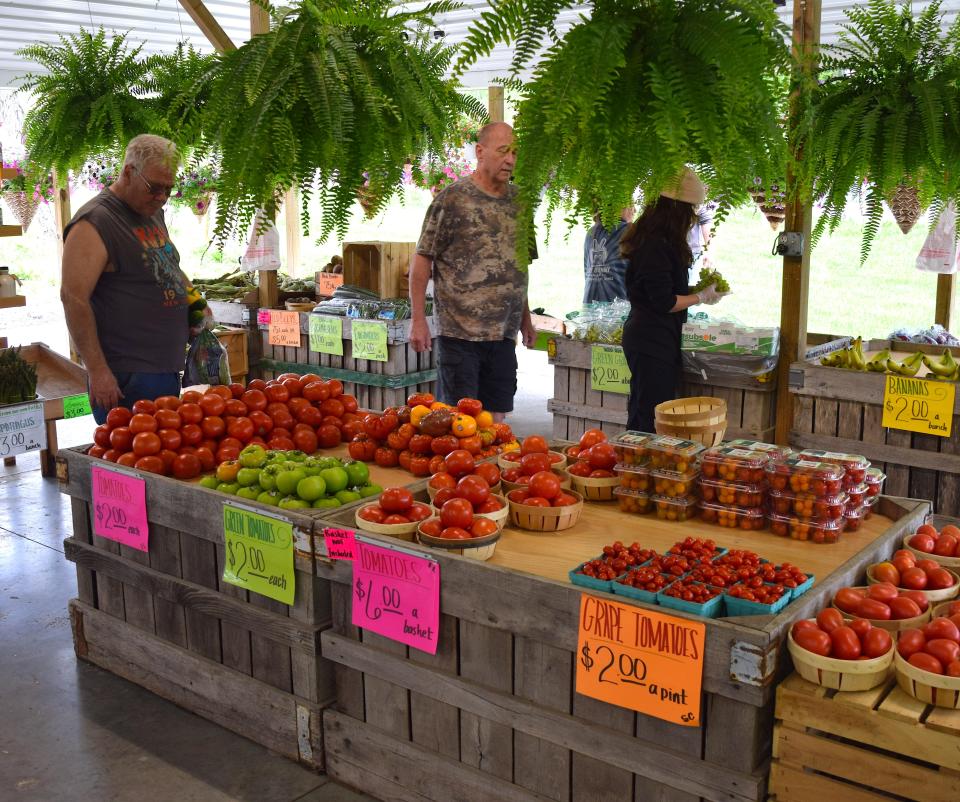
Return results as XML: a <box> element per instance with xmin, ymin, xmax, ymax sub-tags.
<box><xmin>57</xmin><ymin>449</ymin><xmax>334</xmax><ymax>770</ymax></box>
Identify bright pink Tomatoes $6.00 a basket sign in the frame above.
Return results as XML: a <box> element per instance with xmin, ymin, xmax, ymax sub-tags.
<box><xmin>352</xmin><ymin>540</ymin><xmax>440</xmax><ymax>654</ymax></box>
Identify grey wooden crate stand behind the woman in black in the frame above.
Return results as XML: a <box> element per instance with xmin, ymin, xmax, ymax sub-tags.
<box><xmin>547</xmin><ymin>337</ymin><xmax>777</xmax><ymax>441</ymax></box>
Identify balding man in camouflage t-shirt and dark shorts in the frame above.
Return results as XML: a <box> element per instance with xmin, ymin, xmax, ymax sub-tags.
<box><xmin>410</xmin><ymin>123</ymin><xmax>536</xmax><ymax>420</ymax></box>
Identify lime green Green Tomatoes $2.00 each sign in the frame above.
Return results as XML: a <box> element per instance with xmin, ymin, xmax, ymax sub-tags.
<box><xmin>223</xmin><ymin>504</ymin><xmax>294</xmax><ymax>604</ymax></box>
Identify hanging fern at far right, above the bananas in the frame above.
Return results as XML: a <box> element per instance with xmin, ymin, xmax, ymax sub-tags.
<box><xmin>798</xmin><ymin>0</ymin><xmax>960</xmax><ymax>264</ymax></box>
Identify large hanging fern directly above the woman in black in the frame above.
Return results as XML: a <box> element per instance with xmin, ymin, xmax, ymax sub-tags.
<box><xmin>457</xmin><ymin>0</ymin><xmax>791</xmax><ymax>260</ymax></box>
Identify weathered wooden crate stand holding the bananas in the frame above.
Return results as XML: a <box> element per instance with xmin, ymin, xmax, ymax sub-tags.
<box><xmin>790</xmin><ymin>354</ymin><xmax>960</xmax><ymax>516</ymax></box>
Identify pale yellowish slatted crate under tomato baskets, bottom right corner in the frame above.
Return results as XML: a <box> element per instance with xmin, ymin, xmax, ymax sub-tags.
<box><xmin>770</xmin><ymin>674</ymin><xmax>960</xmax><ymax>802</ymax></box>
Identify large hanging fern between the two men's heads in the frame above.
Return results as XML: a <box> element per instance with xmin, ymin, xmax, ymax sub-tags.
<box><xmin>185</xmin><ymin>0</ymin><xmax>486</xmax><ymax>241</ymax></box>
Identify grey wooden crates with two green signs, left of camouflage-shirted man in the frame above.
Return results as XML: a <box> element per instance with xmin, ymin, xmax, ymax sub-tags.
<box><xmin>259</xmin><ymin>312</ymin><xmax>437</xmax><ymax>410</ymax></box>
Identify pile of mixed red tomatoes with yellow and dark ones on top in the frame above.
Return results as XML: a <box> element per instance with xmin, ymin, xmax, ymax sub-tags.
<box><xmin>348</xmin><ymin>393</ymin><xmax>514</xmax><ymax>476</ymax></box>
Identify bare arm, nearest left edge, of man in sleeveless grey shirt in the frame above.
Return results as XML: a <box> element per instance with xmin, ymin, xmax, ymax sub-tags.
<box><xmin>60</xmin><ymin>220</ymin><xmax>123</xmax><ymax>409</ymax></box>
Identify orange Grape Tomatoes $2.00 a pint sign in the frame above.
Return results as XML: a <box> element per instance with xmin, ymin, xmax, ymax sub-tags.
<box><xmin>576</xmin><ymin>593</ymin><xmax>707</xmax><ymax>727</ymax></box>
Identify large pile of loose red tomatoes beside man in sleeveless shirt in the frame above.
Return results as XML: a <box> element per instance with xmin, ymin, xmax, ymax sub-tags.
<box><xmin>87</xmin><ymin>373</ymin><xmax>363</xmax><ymax>479</ymax></box>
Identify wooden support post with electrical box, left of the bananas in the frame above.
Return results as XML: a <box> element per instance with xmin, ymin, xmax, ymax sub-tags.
<box><xmin>776</xmin><ymin>0</ymin><xmax>823</xmax><ymax>443</ymax></box>
